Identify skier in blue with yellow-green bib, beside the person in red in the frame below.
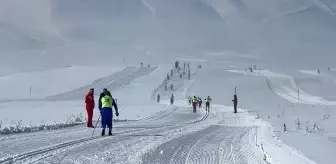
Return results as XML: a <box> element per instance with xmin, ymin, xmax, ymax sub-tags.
<box><xmin>98</xmin><ymin>88</ymin><xmax>119</xmax><ymax>136</ymax></box>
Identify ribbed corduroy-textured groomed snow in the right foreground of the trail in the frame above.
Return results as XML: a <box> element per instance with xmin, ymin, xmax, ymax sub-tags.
<box><xmin>143</xmin><ymin>125</ymin><xmax>264</xmax><ymax>164</ymax></box>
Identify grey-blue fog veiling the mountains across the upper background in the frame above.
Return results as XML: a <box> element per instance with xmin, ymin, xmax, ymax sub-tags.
<box><xmin>0</xmin><ymin>0</ymin><xmax>336</xmax><ymax>68</ymax></box>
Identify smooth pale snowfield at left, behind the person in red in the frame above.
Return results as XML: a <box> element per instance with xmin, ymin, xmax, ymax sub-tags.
<box><xmin>0</xmin><ymin>66</ymin><xmax>121</xmax><ymax>100</ymax></box>
